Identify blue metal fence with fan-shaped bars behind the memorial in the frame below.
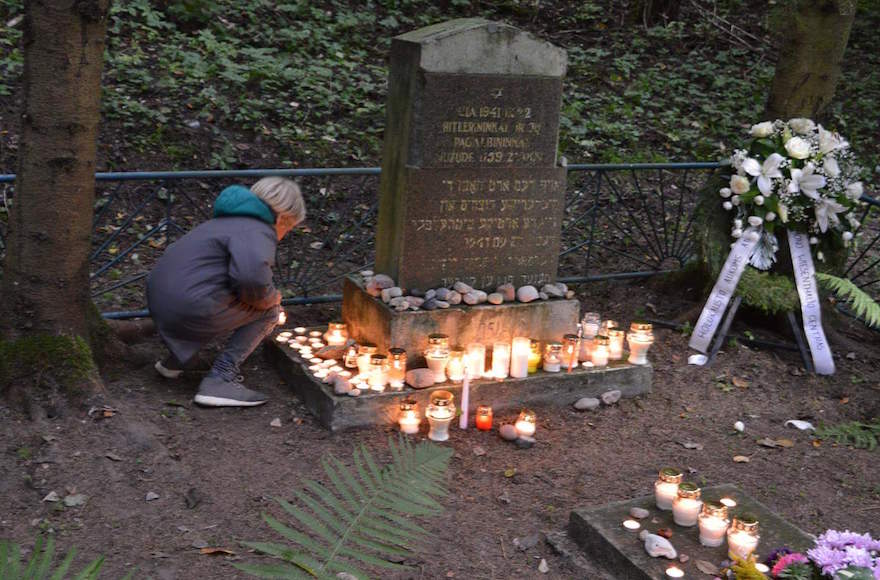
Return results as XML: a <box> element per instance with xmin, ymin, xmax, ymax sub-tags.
<box><xmin>0</xmin><ymin>162</ymin><xmax>880</xmax><ymax>318</ymax></box>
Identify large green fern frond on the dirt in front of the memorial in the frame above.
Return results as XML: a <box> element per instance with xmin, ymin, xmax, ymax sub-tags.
<box><xmin>236</xmin><ymin>437</ymin><xmax>452</xmax><ymax>579</ymax></box>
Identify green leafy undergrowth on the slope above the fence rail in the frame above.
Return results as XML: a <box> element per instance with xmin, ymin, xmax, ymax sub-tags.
<box><xmin>0</xmin><ymin>0</ymin><xmax>880</xmax><ymax>172</ymax></box>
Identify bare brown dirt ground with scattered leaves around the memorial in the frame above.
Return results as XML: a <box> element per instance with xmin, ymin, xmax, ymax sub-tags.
<box><xmin>0</xmin><ymin>286</ymin><xmax>880</xmax><ymax>579</ymax></box>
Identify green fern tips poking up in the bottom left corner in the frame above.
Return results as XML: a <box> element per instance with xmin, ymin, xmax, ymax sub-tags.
<box><xmin>0</xmin><ymin>536</ymin><xmax>108</xmax><ymax>580</ymax></box>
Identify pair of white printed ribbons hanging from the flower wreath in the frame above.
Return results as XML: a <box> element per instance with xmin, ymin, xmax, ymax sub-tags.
<box><xmin>688</xmin><ymin>227</ymin><xmax>834</xmax><ymax>375</ymax></box>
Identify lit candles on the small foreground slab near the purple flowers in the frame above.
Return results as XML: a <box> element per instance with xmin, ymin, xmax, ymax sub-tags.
<box><xmin>640</xmin><ymin>467</ymin><xmax>760</xmax><ymax>578</ymax></box>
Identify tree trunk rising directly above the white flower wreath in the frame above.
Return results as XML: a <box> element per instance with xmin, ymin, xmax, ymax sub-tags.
<box><xmin>766</xmin><ymin>0</ymin><xmax>855</xmax><ymax>120</ymax></box>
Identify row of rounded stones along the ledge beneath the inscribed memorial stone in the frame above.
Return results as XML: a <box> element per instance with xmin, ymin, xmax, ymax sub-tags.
<box><xmin>360</xmin><ymin>270</ymin><xmax>574</xmax><ymax>312</ymax></box>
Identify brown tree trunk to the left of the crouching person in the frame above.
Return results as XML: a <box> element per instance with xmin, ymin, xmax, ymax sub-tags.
<box><xmin>0</xmin><ymin>0</ymin><xmax>110</xmax><ymax>398</ymax></box>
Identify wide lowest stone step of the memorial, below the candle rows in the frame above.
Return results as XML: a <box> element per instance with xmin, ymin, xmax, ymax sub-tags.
<box><xmin>263</xmin><ymin>336</ymin><xmax>653</xmax><ymax>432</ymax></box>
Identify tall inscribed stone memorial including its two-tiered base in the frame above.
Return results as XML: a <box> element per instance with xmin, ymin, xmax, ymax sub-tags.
<box><xmin>267</xmin><ymin>19</ymin><xmax>651</xmax><ymax>430</ymax></box>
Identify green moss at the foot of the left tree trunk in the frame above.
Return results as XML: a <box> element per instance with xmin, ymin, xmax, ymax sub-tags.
<box><xmin>0</xmin><ymin>333</ymin><xmax>96</xmax><ymax>390</ymax></box>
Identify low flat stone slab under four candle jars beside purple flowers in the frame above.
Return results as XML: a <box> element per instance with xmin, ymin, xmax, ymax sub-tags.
<box><xmin>568</xmin><ymin>479</ymin><xmax>813</xmax><ymax>580</ymax></box>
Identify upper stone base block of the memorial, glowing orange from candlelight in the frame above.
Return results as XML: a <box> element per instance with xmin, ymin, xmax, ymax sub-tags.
<box><xmin>342</xmin><ymin>278</ymin><xmax>580</xmax><ymax>368</ymax></box>
